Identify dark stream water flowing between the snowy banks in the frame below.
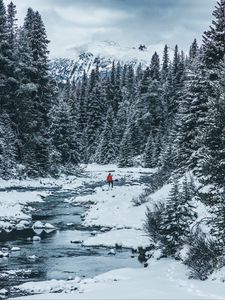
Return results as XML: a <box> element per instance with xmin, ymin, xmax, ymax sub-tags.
<box><xmin>0</xmin><ymin>183</ymin><xmax>141</xmax><ymax>299</ymax></box>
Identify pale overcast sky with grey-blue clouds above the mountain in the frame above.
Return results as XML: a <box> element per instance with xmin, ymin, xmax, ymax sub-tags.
<box><xmin>5</xmin><ymin>0</ymin><xmax>216</xmax><ymax>57</ymax></box>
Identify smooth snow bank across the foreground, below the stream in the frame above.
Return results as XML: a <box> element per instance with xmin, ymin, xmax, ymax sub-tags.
<box><xmin>13</xmin><ymin>259</ymin><xmax>225</xmax><ymax>300</ymax></box>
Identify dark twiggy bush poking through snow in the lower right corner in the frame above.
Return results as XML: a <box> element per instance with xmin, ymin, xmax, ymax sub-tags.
<box><xmin>184</xmin><ymin>232</ymin><xmax>222</xmax><ymax>280</ymax></box>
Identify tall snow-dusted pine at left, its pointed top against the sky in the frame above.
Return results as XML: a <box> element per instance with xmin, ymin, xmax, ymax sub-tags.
<box><xmin>15</xmin><ymin>9</ymin><xmax>54</xmax><ymax>176</ymax></box>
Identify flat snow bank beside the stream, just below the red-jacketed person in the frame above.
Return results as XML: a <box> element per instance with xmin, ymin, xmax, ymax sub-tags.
<box><xmin>71</xmin><ymin>185</ymin><xmax>146</xmax><ymax>229</ymax></box>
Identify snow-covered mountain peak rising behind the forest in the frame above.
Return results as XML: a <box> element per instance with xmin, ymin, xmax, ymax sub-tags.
<box><xmin>51</xmin><ymin>41</ymin><xmax>173</xmax><ymax>81</ymax></box>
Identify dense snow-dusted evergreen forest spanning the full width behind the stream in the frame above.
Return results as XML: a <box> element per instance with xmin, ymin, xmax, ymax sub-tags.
<box><xmin>0</xmin><ymin>0</ymin><xmax>225</xmax><ymax>190</ymax></box>
